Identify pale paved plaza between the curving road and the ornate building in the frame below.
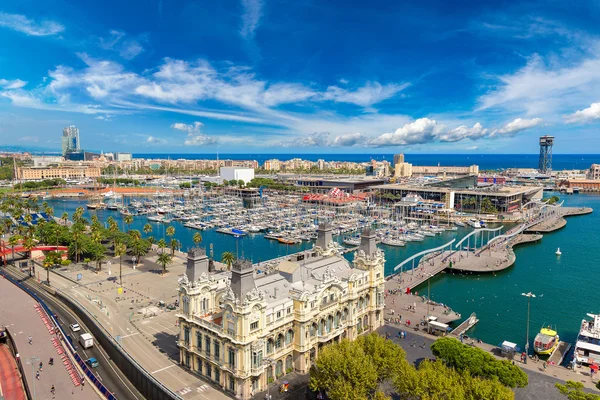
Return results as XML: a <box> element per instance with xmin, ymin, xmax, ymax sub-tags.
<box><xmin>9</xmin><ymin>248</ymin><xmax>231</xmax><ymax>400</ymax></box>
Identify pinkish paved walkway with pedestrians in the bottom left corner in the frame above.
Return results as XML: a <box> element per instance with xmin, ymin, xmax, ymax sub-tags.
<box><xmin>0</xmin><ymin>276</ymin><xmax>99</xmax><ymax>400</ymax></box>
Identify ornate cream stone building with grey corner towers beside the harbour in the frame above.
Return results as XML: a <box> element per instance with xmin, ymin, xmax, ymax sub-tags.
<box><xmin>178</xmin><ymin>224</ymin><xmax>385</xmax><ymax>399</ymax></box>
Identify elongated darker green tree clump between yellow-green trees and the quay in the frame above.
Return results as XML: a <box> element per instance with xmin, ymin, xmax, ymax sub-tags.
<box><xmin>431</xmin><ymin>337</ymin><xmax>528</xmax><ymax>388</ymax></box>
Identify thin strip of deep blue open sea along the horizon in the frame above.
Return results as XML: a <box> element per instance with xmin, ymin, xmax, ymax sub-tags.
<box><xmin>133</xmin><ymin>153</ymin><xmax>600</xmax><ymax>170</ymax></box>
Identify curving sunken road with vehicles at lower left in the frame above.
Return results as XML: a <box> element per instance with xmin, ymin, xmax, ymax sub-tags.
<box><xmin>4</xmin><ymin>267</ymin><xmax>145</xmax><ymax>400</ymax></box>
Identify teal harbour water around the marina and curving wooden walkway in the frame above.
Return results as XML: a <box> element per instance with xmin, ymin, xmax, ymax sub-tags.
<box><xmin>43</xmin><ymin>192</ymin><xmax>600</xmax><ymax>354</ymax></box>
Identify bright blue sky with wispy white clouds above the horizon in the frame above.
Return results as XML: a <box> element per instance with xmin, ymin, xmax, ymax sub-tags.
<box><xmin>0</xmin><ymin>0</ymin><xmax>600</xmax><ymax>154</ymax></box>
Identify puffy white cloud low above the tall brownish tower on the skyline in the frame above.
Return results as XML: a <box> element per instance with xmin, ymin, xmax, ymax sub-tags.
<box><xmin>368</xmin><ymin>118</ymin><xmax>441</xmax><ymax>147</ymax></box>
